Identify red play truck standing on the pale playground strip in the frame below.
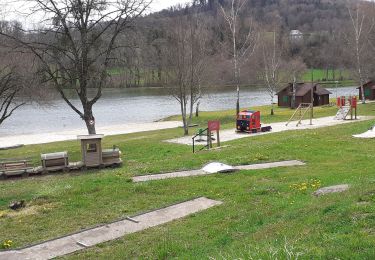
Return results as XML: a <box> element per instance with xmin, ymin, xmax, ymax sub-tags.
<box><xmin>236</xmin><ymin>110</ymin><xmax>272</xmax><ymax>133</ymax></box>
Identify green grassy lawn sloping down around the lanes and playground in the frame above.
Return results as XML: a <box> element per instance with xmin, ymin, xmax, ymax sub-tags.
<box><xmin>0</xmin><ymin>103</ymin><xmax>375</xmax><ymax>259</ymax></box>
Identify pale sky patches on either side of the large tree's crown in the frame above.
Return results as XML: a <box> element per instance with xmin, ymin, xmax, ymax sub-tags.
<box><xmin>0</xmin><ymin>0</ymin><xmax>191</xmax><ymax>26</ymax></box>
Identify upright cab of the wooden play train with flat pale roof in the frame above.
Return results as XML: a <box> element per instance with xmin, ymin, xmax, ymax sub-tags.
<box><xmin>78</xmin><ymin>135</ymin><xmax>104</xmax><ymax>167</ymax></box>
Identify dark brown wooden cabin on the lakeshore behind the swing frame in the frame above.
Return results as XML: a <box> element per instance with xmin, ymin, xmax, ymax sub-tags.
<box><xmin>277</xmin><ymin>83</ymin><xmax>332</xmax><ymax>108</ymax></box>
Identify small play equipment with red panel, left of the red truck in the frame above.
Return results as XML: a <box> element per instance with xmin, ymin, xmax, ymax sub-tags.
<box><xmin>192</xmin><ymin>120</ymin><xmax>220</xmax><ymax>153</ymax></box>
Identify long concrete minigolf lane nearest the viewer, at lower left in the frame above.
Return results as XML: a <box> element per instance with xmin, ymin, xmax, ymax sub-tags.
<box><xmin>0</xmin><ymin>197</ymin><xmax>222</xmax><ymax>260</ymax></box>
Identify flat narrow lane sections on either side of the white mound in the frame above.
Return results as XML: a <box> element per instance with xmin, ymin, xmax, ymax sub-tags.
<box><xmin>132</xmin><ymin>160</ymin><xmax>305</xmax><ymax>182</ymax></box>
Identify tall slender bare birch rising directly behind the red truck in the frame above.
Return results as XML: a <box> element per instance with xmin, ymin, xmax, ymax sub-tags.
<box><xmin>220</xmin><ymin>0</ymin><xmax>258</xmax><ymax>114</ymax></box>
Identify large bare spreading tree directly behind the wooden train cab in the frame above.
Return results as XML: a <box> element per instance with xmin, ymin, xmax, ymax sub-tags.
<box><xmin>0</xmin><ymin>0</ymin><xmax>151</xmax><ymax>134</ymax></box>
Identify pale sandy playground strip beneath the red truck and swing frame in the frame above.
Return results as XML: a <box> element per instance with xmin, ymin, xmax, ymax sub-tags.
<box><xmin>166</xmin><ymin>116</ymin><xmax>375</xmax><ymax>145</ymax></box>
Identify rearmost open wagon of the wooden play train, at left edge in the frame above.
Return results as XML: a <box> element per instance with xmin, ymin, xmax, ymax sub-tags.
<box><xmin>0</xmin><ymin>159</ymin><xmax>33</xmax><ymax>178</ymax></box>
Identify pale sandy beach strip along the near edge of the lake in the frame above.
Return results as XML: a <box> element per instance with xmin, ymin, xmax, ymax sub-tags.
<box><xmin>0</xmin><ymin>121</ymin><xmax>181</xmax><ymax>148</ymax></box>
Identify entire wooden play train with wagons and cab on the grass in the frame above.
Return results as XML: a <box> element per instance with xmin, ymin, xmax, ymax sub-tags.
<box><xmin>0</xmin><ymin>135</ymin><xmax>122</xmax><ymax>178</ymax></box>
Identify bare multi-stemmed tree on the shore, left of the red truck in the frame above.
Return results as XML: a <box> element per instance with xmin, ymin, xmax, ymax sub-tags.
<box><xmin>164</xmin><ymin>15</ymin><xmax>206</xmax><ymax>135</ymax></box>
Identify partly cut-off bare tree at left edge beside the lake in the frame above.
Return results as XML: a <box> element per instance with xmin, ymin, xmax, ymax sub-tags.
<box><xmin>0</xmin><ymin>66</ymin><xmax>25</xmax><ymax>125</ymax></box>
